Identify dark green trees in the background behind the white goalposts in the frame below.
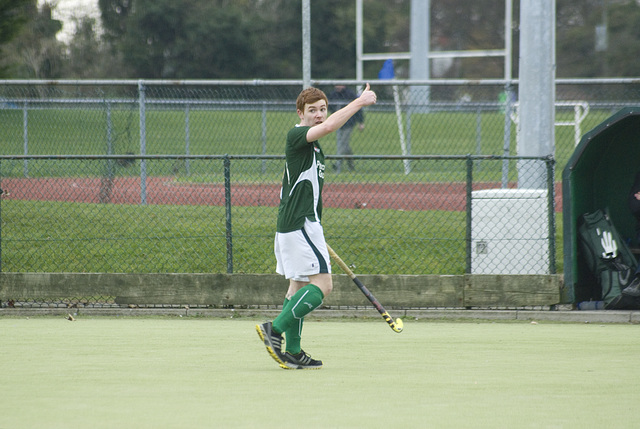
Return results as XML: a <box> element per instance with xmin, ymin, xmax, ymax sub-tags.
<box><xmin>0</xmin><ymin>0</ymin><xmax>640</xmax><ymax>79</ymax></box>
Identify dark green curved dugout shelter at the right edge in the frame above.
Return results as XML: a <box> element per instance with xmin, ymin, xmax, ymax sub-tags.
<box><xmin>562</xmin><ymin>107</ymin><xmax>640</xmax><ymax>303</ymax></box>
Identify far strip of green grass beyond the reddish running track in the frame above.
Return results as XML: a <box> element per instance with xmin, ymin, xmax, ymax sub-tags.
<box><xmin>0</xmin><ymin>105</ymin><xmax>612</xmax><ymax>174</ymax></box>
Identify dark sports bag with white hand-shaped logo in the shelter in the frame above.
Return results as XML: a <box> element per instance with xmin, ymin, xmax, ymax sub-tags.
<box><xmin>578</xmin><ymin>210</ymin><xmax>637</xmax><ymax>310</ymax></box>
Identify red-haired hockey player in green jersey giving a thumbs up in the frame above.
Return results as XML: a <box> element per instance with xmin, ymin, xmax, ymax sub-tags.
<box><xmin>256</xmin><ymin>83</ymin><xmax>376</xmax><ymax>369</ymax></box>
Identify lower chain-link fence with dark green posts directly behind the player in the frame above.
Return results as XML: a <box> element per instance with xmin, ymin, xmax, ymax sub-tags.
<box><xmin>0</xmin><ymin>155</ymin><xmax>555</xmax><ymax>274</ymax></box>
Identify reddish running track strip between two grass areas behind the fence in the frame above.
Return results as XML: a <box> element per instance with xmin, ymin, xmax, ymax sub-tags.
<box><xmin>2</xmin><ymin>177</ymin><xmax>562</xmax><ymax>212</ymax></box>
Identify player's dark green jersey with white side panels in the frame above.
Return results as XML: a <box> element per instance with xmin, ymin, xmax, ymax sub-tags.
<box><xmin>277</xmin><ymin>126</ymin><xmax>324</xmax><ymax>232</ymax></box>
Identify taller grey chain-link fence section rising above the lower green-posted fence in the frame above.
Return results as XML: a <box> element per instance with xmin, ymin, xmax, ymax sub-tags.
<box><xmin>0</xmin><ymin>79</ymin><xmax>640</xmax><ymax>163</ymax></box>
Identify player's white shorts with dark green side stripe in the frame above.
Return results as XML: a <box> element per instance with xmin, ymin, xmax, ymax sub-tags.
<box><xmin>274</xmin><ymin>219</ymin><xmax>331</xmax><ymax>282</ymax></box>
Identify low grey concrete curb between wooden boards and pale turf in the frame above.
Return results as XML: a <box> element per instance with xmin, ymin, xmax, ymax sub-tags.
<box><xmin>0</xmin><ymin>307</ymin><xmax>640</xmax><ymax>324</ymax></box>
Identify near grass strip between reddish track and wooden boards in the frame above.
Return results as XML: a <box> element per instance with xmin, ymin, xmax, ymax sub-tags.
<box><xmin>2</xmin><ymin>196</ymin><xmax>563</xmax><ymax>274</ymax></box>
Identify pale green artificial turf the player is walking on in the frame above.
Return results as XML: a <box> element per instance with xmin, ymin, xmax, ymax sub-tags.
<box><xmin>0</xmin><ymin>317</ymin><xmax>640</xmax><ymax>429</ymax></box>
